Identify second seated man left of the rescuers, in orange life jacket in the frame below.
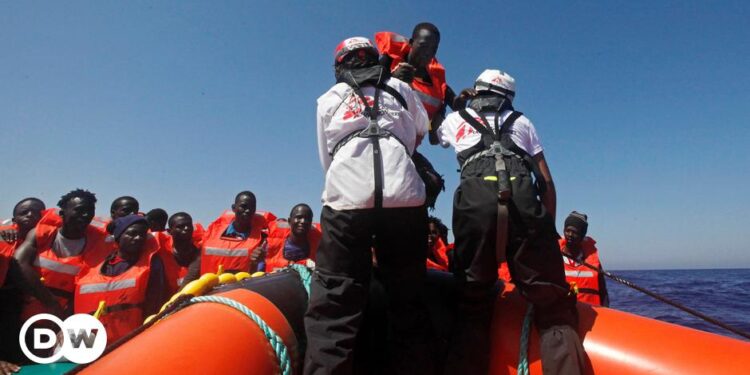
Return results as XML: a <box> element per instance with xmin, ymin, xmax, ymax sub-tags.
<box><xmin>201</xmin><ymin>191</ymin><xmax>267</xmax><ymax>274</ymax></box>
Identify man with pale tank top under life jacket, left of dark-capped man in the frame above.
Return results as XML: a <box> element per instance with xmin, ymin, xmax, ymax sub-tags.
<box><xmin>14</xmin><ymin>189</ymin><xmax>111</xmax><ymax>318</ymax></box>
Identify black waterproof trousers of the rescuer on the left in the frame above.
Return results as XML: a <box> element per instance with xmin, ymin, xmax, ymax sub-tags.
<box><xmin>304</xmin><ymin>207</ymin><xmax>432</xmax><ymax>375</ymax></box>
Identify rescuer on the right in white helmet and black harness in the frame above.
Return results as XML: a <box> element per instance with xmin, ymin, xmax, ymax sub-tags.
<box><xmin>438</xmin><ymin>69</ymin><xmax>584</xmax><ymax>374</ymax></box>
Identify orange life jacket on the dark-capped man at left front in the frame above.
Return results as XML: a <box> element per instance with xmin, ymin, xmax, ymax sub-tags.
<box><xmin>74</xmin><ymin>238</ymin><xmax>159</xmax><ymax>343</ymax></box>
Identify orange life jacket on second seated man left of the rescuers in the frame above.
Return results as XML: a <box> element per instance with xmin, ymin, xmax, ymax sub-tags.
<box><xmin>201</xmin><ymin>211</ymin><xmax>275</xmax><ymax>274</ymax></box>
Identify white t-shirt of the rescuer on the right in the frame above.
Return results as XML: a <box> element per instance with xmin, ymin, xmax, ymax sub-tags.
<box><xmin>437</xmin><ymin>108</ymin><xmax>544</xmax><ymax>157</ymax></box>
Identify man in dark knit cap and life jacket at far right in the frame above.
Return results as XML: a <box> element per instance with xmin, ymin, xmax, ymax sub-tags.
<box><xmin>559</xmin><ymin>211</ymin><xmax>609</xmax><ymax>307</ymax></box>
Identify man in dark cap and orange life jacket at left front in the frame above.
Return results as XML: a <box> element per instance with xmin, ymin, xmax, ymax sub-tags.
<box><xmin>74</xmin><ymin>214</ymin><xmax>169</xmax><ymax>343</ymax></box>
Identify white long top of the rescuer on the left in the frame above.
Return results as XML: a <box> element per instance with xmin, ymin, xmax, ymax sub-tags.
<box><xmin>317</xmin><ymin>78</ymin><xmax>428</xmax><ymax>210</ymax></box>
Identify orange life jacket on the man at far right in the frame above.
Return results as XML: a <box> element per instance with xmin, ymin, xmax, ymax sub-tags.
<box><xmin>559</xmin><ymin>237</ymin><xmax>602</xmax><ymax>306</ymax></box>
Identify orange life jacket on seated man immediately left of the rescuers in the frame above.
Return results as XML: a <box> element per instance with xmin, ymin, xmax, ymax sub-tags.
<box><xmin>266</xmin><ymin>219</ymin><xmax>323</xmax><ymax>272</ymax></box>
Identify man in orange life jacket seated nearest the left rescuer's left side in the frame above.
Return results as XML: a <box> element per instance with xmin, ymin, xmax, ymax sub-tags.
<box><xmin>264</xmin><ymin>203</ymin><xmax>321</xmax><ymax>272</ymax></box>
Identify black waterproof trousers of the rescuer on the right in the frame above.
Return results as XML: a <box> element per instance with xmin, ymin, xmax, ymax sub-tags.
<box><xmin>445</xmin><ymin>158</ymin><xmax>585</xmax><ymax>374</ymax></box>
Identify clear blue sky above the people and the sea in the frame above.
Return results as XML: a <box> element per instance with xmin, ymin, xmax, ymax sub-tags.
<box><xmin>0</xmin><ymin>1</ymin><xmax>750</xmax><ymax>269</ymax></box>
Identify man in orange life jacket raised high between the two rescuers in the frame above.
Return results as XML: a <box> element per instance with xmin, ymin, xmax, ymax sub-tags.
<box><xmin>375</xmin><ymin>22</ymin><xmax>458</xmax><ymax>144</ymax></box>
